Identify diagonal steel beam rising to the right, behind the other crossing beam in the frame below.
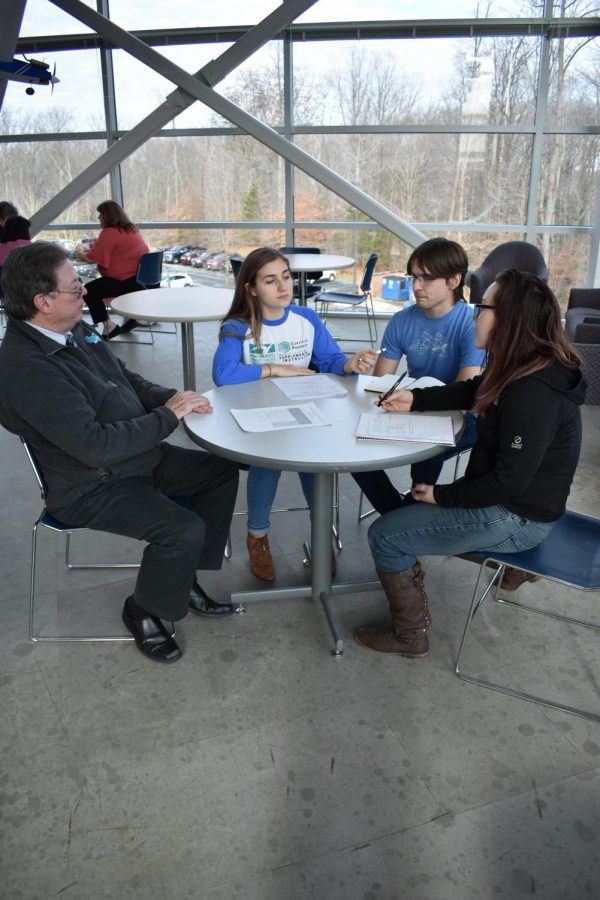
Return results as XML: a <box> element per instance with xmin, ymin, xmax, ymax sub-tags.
<box><xmin>31</xmin><ymin>0</ymin><xmax>316</xmax><ymax>234</ymax></box>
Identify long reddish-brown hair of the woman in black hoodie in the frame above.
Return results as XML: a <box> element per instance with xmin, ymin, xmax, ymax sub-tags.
<box><xmin>473</xmin><ymin>269</ymin><xmax>581</xmax><ymax>414</ymax></box>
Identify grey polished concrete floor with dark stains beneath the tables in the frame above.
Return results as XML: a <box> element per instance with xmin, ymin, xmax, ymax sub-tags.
<box><xmin>0</xmin><ymin>314</ymin><xmax>600</xmax><ymax>900</ymax></box>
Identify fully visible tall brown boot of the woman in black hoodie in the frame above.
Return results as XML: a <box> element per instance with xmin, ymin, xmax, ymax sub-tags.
<box><xmin>354</xmin><ymin>562</ymin><xmax>431</xmax><ymax>659</ymax></box>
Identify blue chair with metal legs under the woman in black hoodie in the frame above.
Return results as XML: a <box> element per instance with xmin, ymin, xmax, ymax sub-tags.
<box><xmin>455</xmin><ymin>511</ymin><xmax>600</xmax><ymax>722</ymax></box>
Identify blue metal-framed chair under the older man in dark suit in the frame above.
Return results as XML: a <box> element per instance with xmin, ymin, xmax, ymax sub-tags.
<box><xmin>20</xmin><ymin>435</ymin><xmax>175</xmax><ymax>643</ymax></box>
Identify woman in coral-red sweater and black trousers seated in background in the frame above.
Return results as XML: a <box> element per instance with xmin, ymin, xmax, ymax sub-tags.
<box><xmin>77</xmin><ymin>200</ymin><xmax>148</xmax><ymax>340</ymax></box>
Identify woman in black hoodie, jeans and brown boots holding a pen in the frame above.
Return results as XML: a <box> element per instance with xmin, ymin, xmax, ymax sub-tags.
<box><xmin>355</xmin><ymin>269</ymin><xmax>586</xmax><ymax>658</ymax></box>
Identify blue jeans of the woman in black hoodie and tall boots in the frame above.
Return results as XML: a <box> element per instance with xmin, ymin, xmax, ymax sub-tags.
<box><xmin>369</xmin><ymin>503</ymin><xmax>554</xmax><ymax>572</ymax></box>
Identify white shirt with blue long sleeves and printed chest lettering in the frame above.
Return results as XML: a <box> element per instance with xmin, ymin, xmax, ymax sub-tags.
<box><xmin>213</xmin><ymin>305</ymin><xmax>347</xmax><ymax>385</ymax></box>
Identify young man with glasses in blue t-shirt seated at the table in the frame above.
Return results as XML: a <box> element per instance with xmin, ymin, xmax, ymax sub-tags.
<box><xmin>353</xmin><ymin>238</ymin><xmax>485</xmax><ymax>514</ymax></box>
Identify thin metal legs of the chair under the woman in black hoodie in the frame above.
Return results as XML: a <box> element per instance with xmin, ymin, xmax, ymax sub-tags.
<box><xmin>454</xmin><ymin>560</ymin><xmax>600</xmax><ymax>722</ymax></box>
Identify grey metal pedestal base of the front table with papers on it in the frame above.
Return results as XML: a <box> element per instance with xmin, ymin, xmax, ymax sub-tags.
<box><xmin>231</xmin><ymin>472</ymin><xmax>381</xmax><ymax>656</ymax></box>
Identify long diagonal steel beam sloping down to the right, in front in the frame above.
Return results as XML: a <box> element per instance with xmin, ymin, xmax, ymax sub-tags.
<box><xmin>40</xmin><ymin>0</ymin><xmax>424</xmax><ymax>246</ymax></box>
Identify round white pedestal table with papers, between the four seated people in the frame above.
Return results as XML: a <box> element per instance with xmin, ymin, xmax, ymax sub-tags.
<box><xmin>184</xmin><ymin>375</ymin><xmax>463</xmax><ymax>656</ymax></box>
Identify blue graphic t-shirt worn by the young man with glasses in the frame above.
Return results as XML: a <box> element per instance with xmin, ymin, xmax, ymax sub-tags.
<box><xmin>381</xmin><ymin>301</ymin><xmax>485</xmax><ymax>384</ymax></box>
